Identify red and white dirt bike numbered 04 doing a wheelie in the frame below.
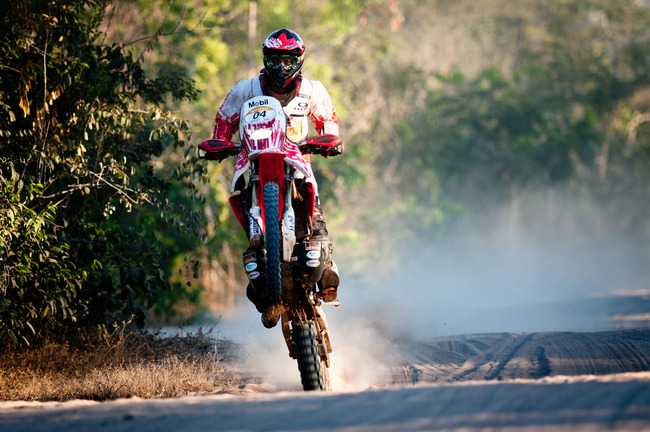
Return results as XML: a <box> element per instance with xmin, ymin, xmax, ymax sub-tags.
<box><xmin>198</xmin><ymin>96</ymin><xmax>342</xmax><ymax>390</ymax></box>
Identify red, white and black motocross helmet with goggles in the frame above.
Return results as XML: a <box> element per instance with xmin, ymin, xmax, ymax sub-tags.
<box><xmin>262</xmin><ymin>28</ymin><xmax>305</xmax><ymax>89</ymax></box>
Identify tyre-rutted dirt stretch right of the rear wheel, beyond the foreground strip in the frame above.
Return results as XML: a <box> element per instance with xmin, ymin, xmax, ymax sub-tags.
<box><xmin>394</xmin><ymin>329</ymin><xmax>650</xmax><ymax>384</ymax></box>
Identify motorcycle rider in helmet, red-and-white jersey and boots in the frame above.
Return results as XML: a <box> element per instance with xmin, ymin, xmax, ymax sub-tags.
<box><xmin>212</xmin><ymin>28</ymin><xmax>339</xmax><ymax>328</ymax></box>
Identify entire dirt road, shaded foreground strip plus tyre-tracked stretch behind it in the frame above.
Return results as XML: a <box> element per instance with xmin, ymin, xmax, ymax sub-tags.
<box><xmin>0</xmin><ymin>330</ymin><xmax>650</xmax><ymax>432</ymax></box>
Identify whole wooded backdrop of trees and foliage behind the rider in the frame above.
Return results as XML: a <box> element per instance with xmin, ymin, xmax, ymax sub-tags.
<box><xmin>0</xmin><ymin>0</ymin><xmax>650</xmax><ymax>344</ymax></box>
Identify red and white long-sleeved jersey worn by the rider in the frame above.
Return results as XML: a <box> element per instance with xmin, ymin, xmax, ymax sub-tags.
<box><xmin>212</xmin><ymin>76</ymin><xmax>339</xmax><ymax>142</ymax></box>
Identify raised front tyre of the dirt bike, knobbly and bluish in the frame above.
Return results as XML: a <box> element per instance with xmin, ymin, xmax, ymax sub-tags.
<box><xmin>264</xmin><ymin>183</ymin><xmax>282</xmax><ymax>300</ymax></box>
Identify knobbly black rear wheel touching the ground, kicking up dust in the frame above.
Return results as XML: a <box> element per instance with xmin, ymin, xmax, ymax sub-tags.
<box><xmin>292</xmin><ymin>320</ymin><xmax>329</xmax><ymax>391</ymax></box>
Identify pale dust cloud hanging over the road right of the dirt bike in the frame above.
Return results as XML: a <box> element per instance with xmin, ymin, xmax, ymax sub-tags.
<box><xmin>350</xmin><ymin>187</ymin><xmax>650</xmax><ymax>339</ymax></box>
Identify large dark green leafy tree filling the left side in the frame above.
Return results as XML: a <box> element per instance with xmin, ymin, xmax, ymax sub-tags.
<box><xmin>0</xmin><ymin>0</ymin><xmax>197</xmax><ymax>342</ymax></box>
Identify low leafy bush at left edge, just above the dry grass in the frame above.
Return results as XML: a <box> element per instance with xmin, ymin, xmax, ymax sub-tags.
<box><xmin>0</xmin><ymin>164</ymin><xmax>87</xmax><ymax>343</ymax></box>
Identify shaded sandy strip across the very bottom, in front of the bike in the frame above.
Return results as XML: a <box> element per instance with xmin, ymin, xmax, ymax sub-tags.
<box><xmin>0</xmin><ymin>373</ymin><xmax>650</xmax><ymax>432</ymax></box>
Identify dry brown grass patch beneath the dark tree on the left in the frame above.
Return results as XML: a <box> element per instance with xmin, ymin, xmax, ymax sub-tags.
<box><xmin>0</xmin><ymin>325</ymin><xmax>241</xmax><ymax>401</ymax></box>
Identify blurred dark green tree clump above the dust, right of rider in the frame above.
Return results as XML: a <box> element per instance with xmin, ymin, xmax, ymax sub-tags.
<box><xmin>402</xmin><ymin>68</ymin><xmax>601</xmax><ymax>199</ymax></box>
